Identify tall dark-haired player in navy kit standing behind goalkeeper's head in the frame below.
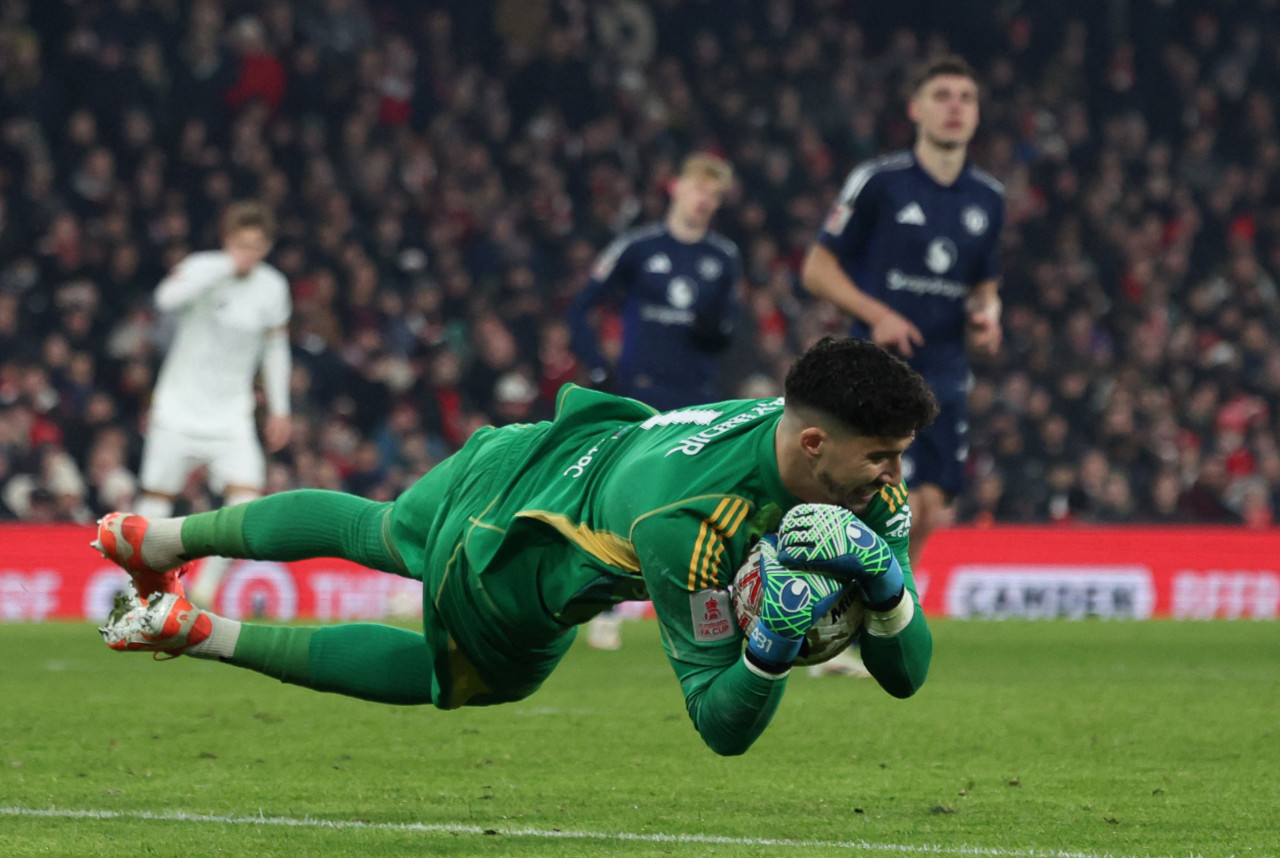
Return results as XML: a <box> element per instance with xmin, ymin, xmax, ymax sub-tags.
<box><xmin>803</xmin><ymin>56</ymin><xmax>1005</xmax><ymax>672</ymax></box>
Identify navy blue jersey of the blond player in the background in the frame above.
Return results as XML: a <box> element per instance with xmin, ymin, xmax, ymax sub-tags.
<box><xmin>568</xmin><ymin>223</ymin><xmax>741</xmax><ymax>411</ymax></box>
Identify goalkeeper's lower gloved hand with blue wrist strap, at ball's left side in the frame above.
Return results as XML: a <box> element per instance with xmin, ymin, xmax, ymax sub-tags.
<box><xmin>746</xmin><ymin>535</ymin><xmax>844</xmax><ymax>674</ymax></box>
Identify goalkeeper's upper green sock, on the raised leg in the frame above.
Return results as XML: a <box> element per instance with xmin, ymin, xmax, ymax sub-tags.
<box><xmin>182</xmin><ymin>489</ymin><xmax>407</xmax><ymax>575</ymax></box>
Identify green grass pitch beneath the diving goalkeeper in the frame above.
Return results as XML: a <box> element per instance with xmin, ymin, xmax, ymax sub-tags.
<box><xmin>0</xmin><ymin>621</ymin><xmax>1280</xmax><ymax>858</ymax></box>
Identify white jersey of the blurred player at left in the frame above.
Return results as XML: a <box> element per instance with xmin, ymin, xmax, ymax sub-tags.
<box><xmin>151</xmin><ymin>252</ymin><xmax>291</xmax><ymax>437</ymax></box>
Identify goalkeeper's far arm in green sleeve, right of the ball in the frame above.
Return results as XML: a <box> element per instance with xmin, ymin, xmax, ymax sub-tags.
<box><xmin>863</xmin><ymin>484</ymin><xmax>933</xmax><ymax>698</ymax></box>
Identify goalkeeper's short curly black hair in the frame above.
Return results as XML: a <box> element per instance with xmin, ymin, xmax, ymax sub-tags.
<box><xmin>785</xmin><ymin>337</ymin><xmax>938</xmax><ymax>438</ymax></box>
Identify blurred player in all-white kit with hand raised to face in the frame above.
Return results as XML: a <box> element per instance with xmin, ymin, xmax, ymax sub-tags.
<box><xmin>137</xmin><ymin>202</ymin><xmax>291</xmax><ymax>604</ymax></box>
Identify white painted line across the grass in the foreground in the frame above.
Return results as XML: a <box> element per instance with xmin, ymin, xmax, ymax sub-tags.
<box><xmin>0</xmin><ymin>807</ymin><xmax>1172</xmax><ymax>858</ymax></box>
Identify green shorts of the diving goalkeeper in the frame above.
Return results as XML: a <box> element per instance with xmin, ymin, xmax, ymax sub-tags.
<box><xmin>390</xmin><ymin>426</ymin><xmax>575</xmax><ymax>709</ymax></box>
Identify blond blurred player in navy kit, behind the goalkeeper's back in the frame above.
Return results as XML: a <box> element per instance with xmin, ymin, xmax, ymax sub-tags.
<box><xmin>568</xmin><ymin>152</ymin><xmax>741</xmax><ymax>649</ymax></box>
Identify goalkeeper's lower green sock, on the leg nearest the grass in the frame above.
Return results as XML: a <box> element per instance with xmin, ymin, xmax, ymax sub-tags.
<box><xmin>235</xmin><ymin>622</ymin><xmax>431</xmax><ymax>704</ymax></box>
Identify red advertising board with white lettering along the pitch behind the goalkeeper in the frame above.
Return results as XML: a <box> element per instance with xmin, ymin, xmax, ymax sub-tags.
<box><xmin>0</xmin><ymin>525</ymin><xmax>1280</xmax><ymax>621</ymax></box>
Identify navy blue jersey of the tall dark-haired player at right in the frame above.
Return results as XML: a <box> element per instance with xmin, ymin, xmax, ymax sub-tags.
<box><xmin>818</xmin><ymin>151</ymin><xmax>1005</xmax><ymax>387</ymax></box>
